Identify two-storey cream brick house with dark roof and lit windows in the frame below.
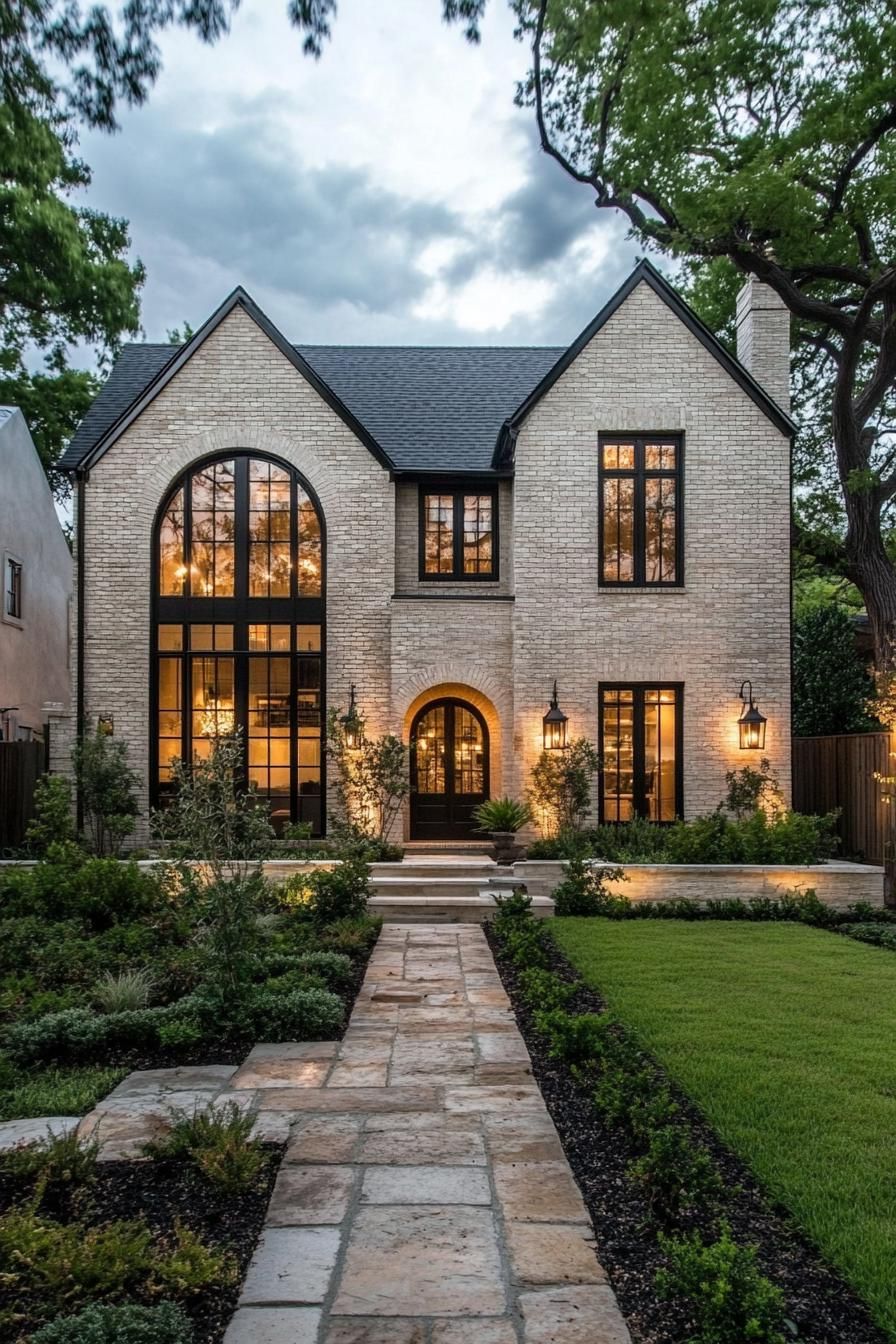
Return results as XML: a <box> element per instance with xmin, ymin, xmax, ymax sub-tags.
<box><xmin>57</xmin><ymin>263</ymin><xmax>793</xmax><ymax>840</ymax></box>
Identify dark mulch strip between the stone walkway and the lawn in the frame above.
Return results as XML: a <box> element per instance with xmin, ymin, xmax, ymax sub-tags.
<box><xmin>486</xmin><ymin>926</ymin><xmax>887</xmax><ymax>1344</ymax></box>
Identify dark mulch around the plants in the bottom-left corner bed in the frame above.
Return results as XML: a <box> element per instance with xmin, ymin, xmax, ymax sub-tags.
<box><xmin>0</xmin><ymin>1144</ymin><xmax>282</xmax><ymax>1344</ymax></box>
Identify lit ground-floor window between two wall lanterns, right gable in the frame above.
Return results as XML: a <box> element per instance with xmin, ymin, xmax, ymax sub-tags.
<box><xmin>599</xmin><ymin>683</ymin><xmax>682</xmax><ymax>821</ymax></box>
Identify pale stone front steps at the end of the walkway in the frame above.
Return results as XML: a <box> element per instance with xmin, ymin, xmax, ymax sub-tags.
<box><xmin>369</xmin><ymin>853</ymin><xmax>553</xmax><ymax>923</ymax></box>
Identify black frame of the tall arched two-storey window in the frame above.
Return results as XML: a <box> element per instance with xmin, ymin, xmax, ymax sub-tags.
<box><xmin>149</xmin><ymin>448</ymin><xmax>326</xmax><ymax>836</ymax></box>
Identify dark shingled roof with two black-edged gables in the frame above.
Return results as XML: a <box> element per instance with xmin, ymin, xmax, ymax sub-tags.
<box><xmin>60</xmin><ymin>261</ymin><xmax>794</xmax><ymax>474</ymax></box>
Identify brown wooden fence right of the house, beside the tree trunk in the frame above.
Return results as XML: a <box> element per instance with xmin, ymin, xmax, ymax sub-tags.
<box><xmin>793</xmin><ymin>732</ymin><xmax>896</xmax><ymax>863</ymax></box>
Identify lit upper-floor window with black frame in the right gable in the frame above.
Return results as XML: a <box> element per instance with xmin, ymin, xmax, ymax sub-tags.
<box><xmin>599</xmin><ymin>434</ymin><xmax>684</xmax><ymax>587</ymax></box>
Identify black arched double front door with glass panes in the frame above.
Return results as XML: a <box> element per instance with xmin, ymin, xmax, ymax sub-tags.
<box><xmin>411</xmin><ymin>699</ymin><xmax>489</xmax><ymax>840</ymax></box>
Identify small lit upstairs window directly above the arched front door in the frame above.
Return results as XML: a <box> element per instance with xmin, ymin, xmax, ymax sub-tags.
<box><xmin>419</xmin><ymin>485</ymin><xmax>498</xmax><ymax>582</ymax></box>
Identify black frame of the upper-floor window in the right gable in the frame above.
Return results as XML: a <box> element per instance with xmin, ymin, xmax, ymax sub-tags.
<box><xmin>598</xmin><ymin>430</ymin><xmax>685</xmax><ymax>589</ymax></box>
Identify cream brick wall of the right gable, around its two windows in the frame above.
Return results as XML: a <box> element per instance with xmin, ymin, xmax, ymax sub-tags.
<box><xmin>513</xmin><ymin>284</ymin><xmax>790</xmax><ymax>816</ymax></box>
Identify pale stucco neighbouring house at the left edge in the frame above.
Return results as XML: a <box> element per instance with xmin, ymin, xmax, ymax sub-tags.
<box><xmin>0</xmin><ymin>406</ymin><xmax>73</xmax><ymax>742</ymax></box>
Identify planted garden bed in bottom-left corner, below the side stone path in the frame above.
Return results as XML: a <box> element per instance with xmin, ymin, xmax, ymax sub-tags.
<box><xmin>0</xmin><ymin>1109</ymin><xmax>281</xmax><ymax>1344</ymax></box>
